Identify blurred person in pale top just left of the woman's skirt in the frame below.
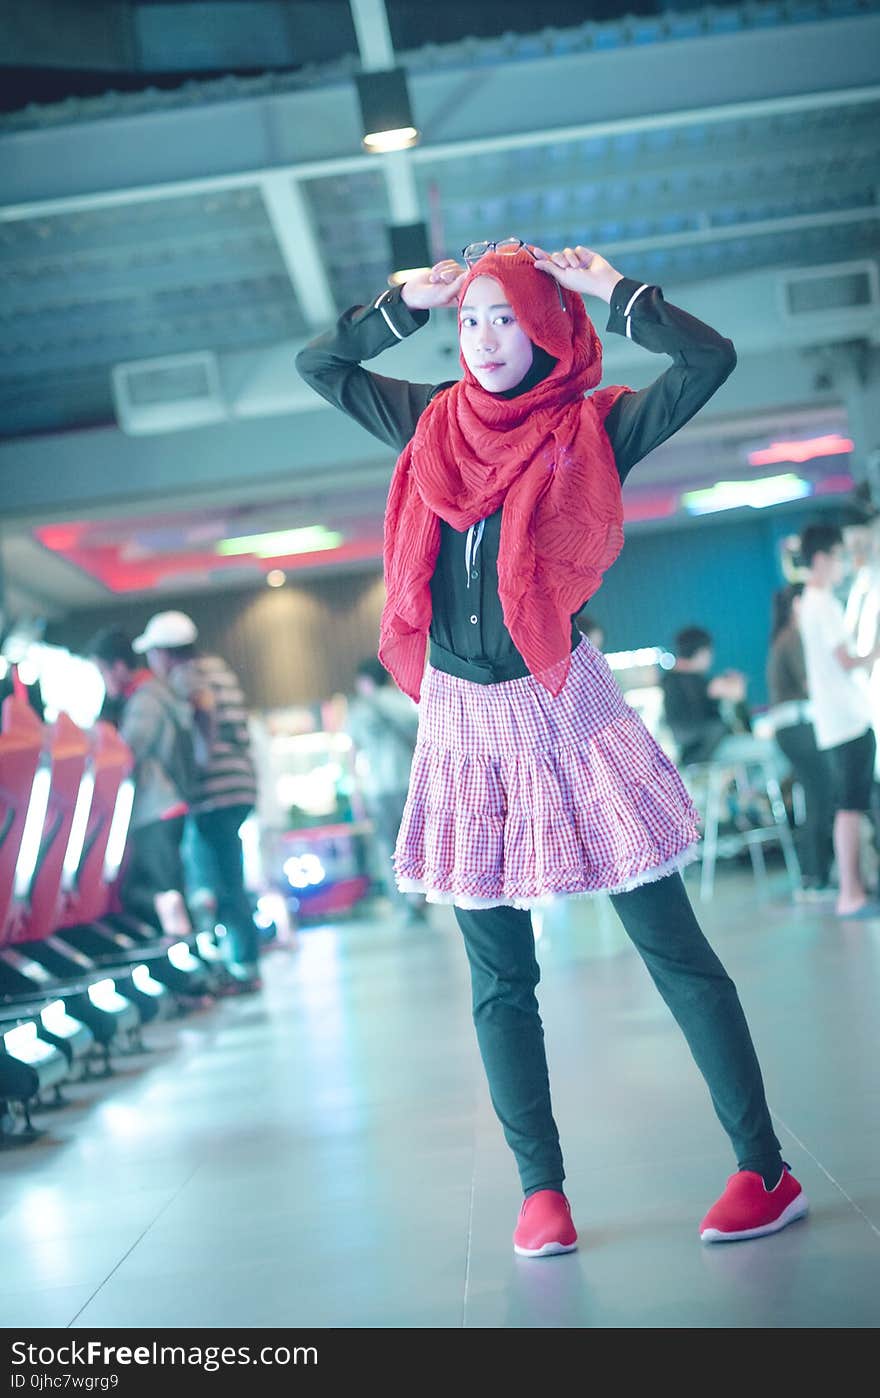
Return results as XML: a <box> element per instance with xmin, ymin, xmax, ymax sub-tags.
<box><xmin>346</xmin><ymin>656</ymin><xmax>427</xmax><ymax>923</ymax></box>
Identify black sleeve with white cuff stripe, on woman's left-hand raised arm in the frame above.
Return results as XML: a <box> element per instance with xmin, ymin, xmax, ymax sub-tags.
<box><xmin>297</xmin><ymin>287</ymin><xmax>435</xmax><ymax>450</ymax></box>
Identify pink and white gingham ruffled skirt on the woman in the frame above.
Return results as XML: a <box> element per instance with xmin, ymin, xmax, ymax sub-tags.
<box><xmin>395</xmin><ymin>639</ymin><xmax>700</xmax><ymax>907</ymax></box>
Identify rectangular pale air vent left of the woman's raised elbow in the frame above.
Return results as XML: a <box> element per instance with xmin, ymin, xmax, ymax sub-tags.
<box><xmin>113</xmin><ymin>350</ymin><xmax>228</xmax><ymax>436</ymax></box>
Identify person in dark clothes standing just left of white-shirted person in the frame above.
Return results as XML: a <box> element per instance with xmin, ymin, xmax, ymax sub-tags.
<box><xmin>767</xmin><ymin>583</ymin><xmax>834</xmax><ymax>899</ymax></box>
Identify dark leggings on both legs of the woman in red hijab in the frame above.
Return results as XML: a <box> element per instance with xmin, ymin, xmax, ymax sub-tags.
<box><xmin>455</xmin><ymin>874</ymin><xmax>781</xmax><ymax>1194</ymax></box>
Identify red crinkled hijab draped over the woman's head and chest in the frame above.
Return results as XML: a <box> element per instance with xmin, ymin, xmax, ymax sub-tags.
<box><xmin>379</xmin><ymin>252</ymin><xmax>630</xmax><ymax>699</ymax></box>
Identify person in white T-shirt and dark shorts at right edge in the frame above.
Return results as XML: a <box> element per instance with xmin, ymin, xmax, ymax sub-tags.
<box><xmin>800</xmin><ymin>523</ymin><xmax>880</xmax><ymax>918</ymax></box>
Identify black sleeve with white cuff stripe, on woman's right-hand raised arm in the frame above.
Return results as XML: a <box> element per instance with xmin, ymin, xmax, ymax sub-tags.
<box><xmin>604</xmin><ymin>277</ymin><xmax>736</xmax><ymax>481</ymax></box>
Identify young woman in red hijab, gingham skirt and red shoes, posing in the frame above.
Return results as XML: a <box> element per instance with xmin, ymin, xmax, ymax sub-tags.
<box><xmin>297</xmin><ymin>239</ymin><xmax>806</xmax><ymax>1257</ymax></box>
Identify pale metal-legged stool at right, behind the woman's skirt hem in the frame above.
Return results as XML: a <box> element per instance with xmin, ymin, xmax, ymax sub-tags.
<box><xmin>681</xmin><ymin>756</ymin><xmax>800</xmax><ymax>903</ymax></box>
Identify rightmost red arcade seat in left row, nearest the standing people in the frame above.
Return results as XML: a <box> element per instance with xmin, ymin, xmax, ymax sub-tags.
<box><xmin>57</xmin><ymin>723</ymin><xmax>133</xmax><ymax>927</ymax></box>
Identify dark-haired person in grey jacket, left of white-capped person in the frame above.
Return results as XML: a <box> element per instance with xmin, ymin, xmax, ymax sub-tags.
<box><xmin>85</xmin><ymin>626</ymin><xmax>193</xmax><ymax>937</ymax></box>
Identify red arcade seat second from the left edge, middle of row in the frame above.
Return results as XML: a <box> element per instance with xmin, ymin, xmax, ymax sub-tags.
<box><xmin>11</xmin><ymin>713</ymin><xmax>88</xmax><ymax>942</ymax></box>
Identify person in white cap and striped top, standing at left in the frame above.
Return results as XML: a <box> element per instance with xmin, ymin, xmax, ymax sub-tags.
<box><xmin>133</xmin><ymin>611</ymin><xmax>262</xmax><ymax>991</ymax></box>
